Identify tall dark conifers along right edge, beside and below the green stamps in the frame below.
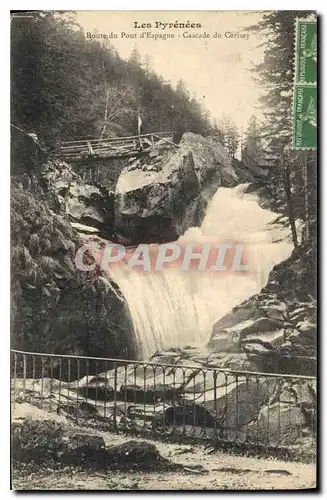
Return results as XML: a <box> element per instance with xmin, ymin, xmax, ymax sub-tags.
<box><xmin>250</xmin><ymin>10</ymin><xmax>317</xmax><ymax>253</ymax></box>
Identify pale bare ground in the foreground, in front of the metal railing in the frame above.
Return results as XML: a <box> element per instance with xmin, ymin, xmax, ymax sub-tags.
<box><xmin>12</xmin><ymin>403</ymin><xmax>316</xmax><ymax>491</ymax></box>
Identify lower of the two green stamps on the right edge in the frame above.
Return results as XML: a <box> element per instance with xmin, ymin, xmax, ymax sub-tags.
<box><xmin>293</xmin><ymin>85</ymin><xmax>317</xmax><ymax>149</ymax></box>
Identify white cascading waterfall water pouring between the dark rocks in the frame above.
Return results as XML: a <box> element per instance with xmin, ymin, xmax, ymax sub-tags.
<box><xmin>111</xmin><ymin>184</ymin><xmax>293</xmax><ymax>359</ymax></box>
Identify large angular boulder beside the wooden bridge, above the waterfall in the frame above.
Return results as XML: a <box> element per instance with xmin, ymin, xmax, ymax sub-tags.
<box><xmin>115</xmin><ymin>133</ymin><xmax>237</xmax><ymax>244</ymax></box>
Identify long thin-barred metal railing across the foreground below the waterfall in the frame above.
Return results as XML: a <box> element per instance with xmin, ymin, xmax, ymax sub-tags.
<box><xmin>11</xmin><ymin>350</ymin><xmax>316</xmax><ymax>449</ymax></box>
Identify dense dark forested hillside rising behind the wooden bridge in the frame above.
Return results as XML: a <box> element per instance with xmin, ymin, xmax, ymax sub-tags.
<box><xmin>11</xmin><ymin>11</ymin><xmax>212</xmax><ymax>145</ymax></box>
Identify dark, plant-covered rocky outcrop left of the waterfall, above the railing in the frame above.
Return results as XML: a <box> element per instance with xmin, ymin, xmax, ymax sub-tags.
<box><xmin>11</xmin><ymin>185</ymin><xmax>135</xmax><ymax>366</ymax></box>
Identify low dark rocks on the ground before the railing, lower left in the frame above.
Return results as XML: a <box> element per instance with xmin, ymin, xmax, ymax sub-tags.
<box><xmin>12</xmin><ymin>420</ymin><xmax>179</xmax><ymax>471</ymax></box>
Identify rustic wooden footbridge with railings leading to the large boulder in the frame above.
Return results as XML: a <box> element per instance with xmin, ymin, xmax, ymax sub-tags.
<box><xmin>57</xmin><ymin>132</ymin><xmax>179</xmax><ymax>162</ymax></box>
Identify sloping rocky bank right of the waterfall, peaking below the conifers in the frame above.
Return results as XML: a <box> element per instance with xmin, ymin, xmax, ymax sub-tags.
<box><xmin>208</xmin><ymin>246</ymin><xmax>317</xmax><ymax>375</ymax></box>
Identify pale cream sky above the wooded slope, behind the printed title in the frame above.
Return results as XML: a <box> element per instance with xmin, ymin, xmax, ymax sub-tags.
<box><xmin>77</xmin><ymin>11</ymin><xmax>263</xmax><ymax>130</ymax></box>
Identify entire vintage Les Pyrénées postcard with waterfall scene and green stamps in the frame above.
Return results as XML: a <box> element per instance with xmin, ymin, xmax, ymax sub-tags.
<box><xmin>10</xmin><ymin>10</ymin><xmax>318</xmax><ymax>491</ymax></box>
